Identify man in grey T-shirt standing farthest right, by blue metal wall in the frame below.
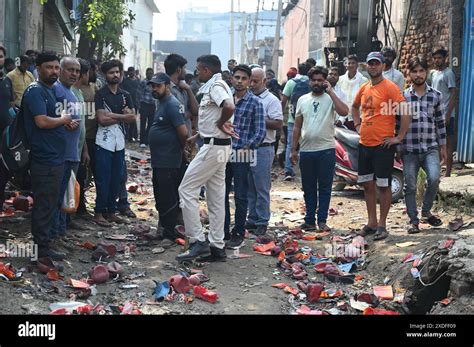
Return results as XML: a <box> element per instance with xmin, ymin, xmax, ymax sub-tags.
<box><xmin>431</xmin><ymin>47</ymin><xmax>457</xmax><ymax>177</ymax></box>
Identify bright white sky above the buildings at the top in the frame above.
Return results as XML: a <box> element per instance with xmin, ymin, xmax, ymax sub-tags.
<box><xmin>153</xmin><ymin>0</ymin><xmax>278</xmax><ymax>41</ymax></box>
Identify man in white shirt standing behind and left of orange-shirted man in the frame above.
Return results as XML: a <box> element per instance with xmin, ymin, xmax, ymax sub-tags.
<box><xmin>338</xmin><ymin>55</ymin><xmax>368</xmax><ymax>129</ymax></box>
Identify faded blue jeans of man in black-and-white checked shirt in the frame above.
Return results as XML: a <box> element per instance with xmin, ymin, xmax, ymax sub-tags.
<box><xmin>403</xmin><ymin>149</ymin><xmax>441</xmax><ymax>224</ymax></box>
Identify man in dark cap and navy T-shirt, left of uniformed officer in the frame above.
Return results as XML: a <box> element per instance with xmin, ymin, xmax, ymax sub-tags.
<box><xmin>148</xmin><ymin>73</ymin><xmax>188</xmax><ymax>241</ymax></box>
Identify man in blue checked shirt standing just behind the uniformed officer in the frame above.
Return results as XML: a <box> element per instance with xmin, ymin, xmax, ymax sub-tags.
<box><xmin>224</xmin><ymin>65</ymin><xmax>266</xmax><ymax>249</ymax></box>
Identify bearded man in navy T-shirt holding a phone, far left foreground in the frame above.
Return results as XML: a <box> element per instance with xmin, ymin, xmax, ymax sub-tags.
<box><xmin>22</xmin><ymin>53</ymin><xmax>77</xmax><ymax>260</ymax></box>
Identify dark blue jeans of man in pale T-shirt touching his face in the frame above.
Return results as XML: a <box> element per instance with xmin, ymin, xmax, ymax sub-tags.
<box><xmin>300</xmin><ymin>149</ymin><xmax>336</xmax><ymax>225</ymax></box>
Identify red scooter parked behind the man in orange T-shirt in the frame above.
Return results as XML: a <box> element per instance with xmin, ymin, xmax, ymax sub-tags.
<box><xmin>334</xmin><ymin>127</ymin><xmax>403</xmax><ymax>202</ymax></box>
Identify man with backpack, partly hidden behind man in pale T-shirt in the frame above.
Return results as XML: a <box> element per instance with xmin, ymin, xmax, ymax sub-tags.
<box><xmin>281</xmin><ymin>63</ymin><xmax>311</xmax><ymax>181</ymax></box>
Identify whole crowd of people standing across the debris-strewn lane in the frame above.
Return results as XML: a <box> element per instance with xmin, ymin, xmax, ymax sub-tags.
<box><xmin>0</xmin><ymin>46</ymin><xmax>456</xmax><ymax>261</ymax></box>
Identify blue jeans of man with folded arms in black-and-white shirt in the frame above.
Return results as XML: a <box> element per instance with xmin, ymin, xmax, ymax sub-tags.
<box><xmin>95</xmin><ymin>146</ymin><xmax>126</xmax><ymax>213</ymax></box>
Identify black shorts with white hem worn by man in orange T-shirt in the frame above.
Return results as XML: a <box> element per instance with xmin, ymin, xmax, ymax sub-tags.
<box><xmin>357</xmin><ymin>144</ymin><xmax>395</xmax><ymax>188</ymax></box>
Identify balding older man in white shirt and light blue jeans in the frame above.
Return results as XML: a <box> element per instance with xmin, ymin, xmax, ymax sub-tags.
<box><xmin>246</xmin><ymin>68</ymin><xmax>283</xmax><ymax>236</ymax></box>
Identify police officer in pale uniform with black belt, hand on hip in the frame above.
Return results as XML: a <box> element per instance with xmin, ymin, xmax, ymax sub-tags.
<box><xmin>176</xmin><ymin>55</ymin><xmax>237</xmax><ymax>261</ymax></box>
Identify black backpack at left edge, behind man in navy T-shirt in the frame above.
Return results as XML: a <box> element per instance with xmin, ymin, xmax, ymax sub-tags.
<box><xmin>0</xmin><ymin>84</ymin><xmax>30</xmax><ymax>174</ymax></box>
